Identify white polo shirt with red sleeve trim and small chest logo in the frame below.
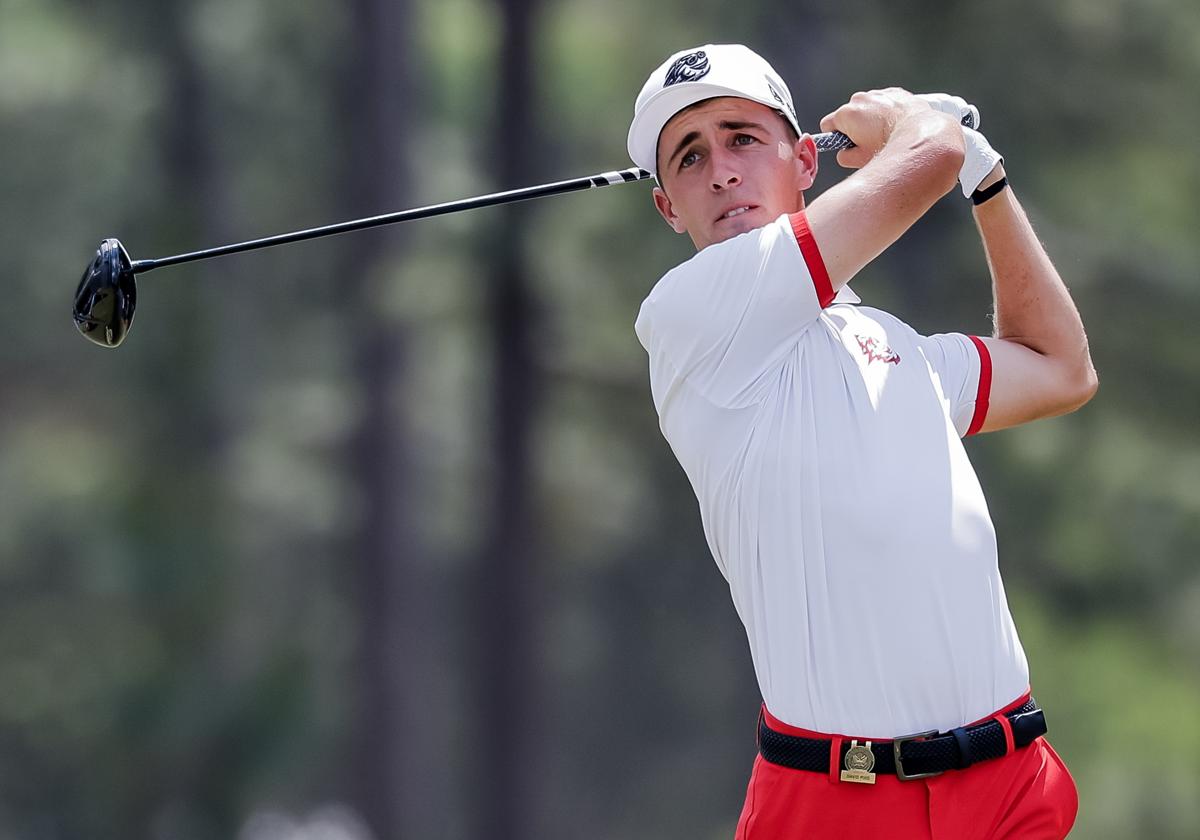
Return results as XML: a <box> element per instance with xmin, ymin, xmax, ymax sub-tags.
<box><xmin>636</xmin><ymin>214</ymin><xmax>1028</xmax><ymax>738</ymax></box>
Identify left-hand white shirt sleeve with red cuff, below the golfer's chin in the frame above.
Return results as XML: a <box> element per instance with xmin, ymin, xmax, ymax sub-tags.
<box><xmin>636</xmin><ymin>212</ymin><xmax>834</xmax><ymax>406</ymax></box>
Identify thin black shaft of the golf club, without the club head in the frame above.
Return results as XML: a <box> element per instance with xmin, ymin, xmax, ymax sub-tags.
<box><xmin>131</xmin><ymin>132</ymin><xmax>853</xmax><ymax>274</ymax></box>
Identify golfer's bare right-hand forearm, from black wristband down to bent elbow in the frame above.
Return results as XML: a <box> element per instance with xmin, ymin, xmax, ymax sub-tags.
<box><xmin>974</xmin><ymin>166</ymin><xmax>1096</xmax><ymax>395</ymax></box>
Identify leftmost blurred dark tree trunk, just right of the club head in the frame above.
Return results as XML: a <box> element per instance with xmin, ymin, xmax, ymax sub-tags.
<box><xmin>132</xmin><ymin>0</ymin><xmax>241</xmax><ymax>835</ymax></box>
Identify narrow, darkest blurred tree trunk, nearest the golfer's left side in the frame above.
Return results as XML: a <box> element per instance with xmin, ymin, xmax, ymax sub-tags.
<box><xmin>472</xmin><ymin>0</ymin><xmax>541</xmax><ymax>840</ymax></box>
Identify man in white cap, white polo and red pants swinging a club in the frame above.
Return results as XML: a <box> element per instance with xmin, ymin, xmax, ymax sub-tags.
<box><xmin>629</xmin><ymin>44</ymin><xmax>1097</xmax><ymax>840</ymax></box>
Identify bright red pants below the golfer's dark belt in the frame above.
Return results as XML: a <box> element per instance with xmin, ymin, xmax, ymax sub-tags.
<box><xmin>734</xmin><ymin>698</ymin><xmax>1079</xmax><ymax>840</ymax></box>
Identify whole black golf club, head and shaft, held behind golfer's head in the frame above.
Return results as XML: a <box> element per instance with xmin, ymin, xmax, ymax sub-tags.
<box><xmin>74</xmin><ymin>125</ymin><xmax>854</xmax><ymax>347</ymax></box>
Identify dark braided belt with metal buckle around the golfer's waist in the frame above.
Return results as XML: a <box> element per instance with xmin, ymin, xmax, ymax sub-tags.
<box><xmin>758</xmin><ymin>698</ymin><xmax>1046</xmax><ymax>782</ymax></box>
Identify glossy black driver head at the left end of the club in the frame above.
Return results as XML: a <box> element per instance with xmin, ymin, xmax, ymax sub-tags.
<box><xmin>74</xmin><ymin>239</ymin><xmax>138</xmax><ymax>347</ymax></box>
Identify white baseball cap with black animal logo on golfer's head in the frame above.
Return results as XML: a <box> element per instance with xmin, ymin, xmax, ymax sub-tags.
<box><xmin>628</xmin><ymin>43</ymin><xmax>803</xmax><ymax>172</ymax></box>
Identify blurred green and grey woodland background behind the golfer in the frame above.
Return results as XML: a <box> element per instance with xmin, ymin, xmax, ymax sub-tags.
<box><xmin>0</xmin><ymin>0</ymin><xmax>1200</xmax><ymax>840</ymax></box>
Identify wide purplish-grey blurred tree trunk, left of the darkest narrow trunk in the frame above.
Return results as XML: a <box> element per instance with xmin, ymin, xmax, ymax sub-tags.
<box><xmin>337</xmin><ymin>0</ymin><xmax>442</xmax><ymax>840</ymax></box>
